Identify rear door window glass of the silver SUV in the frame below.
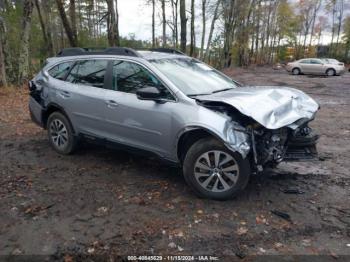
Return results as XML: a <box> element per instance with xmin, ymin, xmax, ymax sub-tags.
<box><xmin>66</xmin><ymin>59</ymin><xmax>108</xmax><ymax>88</ymax></box>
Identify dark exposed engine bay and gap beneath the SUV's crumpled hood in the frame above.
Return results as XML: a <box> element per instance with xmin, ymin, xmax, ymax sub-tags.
<box><xmin>197</xmin><ymin>101</ymin><xmax>318</xmax><ymax>171</ymax></box>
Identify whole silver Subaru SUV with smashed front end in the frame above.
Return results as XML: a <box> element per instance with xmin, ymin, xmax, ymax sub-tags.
<box><xmin>29</xmin><ymin>48</ymin><xmax>319</xmax><ymax>200</ymax></box>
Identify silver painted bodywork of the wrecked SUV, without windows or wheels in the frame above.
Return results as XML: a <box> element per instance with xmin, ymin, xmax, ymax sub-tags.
<box><xmin>30</xmin><ymin>52</ymin><xmax>318</xmax><ymax>162</ymax></box>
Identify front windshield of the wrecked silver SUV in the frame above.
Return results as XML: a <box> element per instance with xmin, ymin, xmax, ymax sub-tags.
<box><xmin>150</xmin><ymin>57</ymin><xmax>237</xmax><ymax>96</ymax></box>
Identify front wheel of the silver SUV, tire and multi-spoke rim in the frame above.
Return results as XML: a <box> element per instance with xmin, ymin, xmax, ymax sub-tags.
<box><xmin>183</xmin><ymin>138</ymin><xmax>250</xmax><ymax>200</ymax></box>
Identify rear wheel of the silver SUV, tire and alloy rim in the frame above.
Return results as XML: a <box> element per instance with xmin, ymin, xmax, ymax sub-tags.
<box><xmin>47</xmin><ymin>112</ymin><xmax>77</xmax><ymax>155</ymax></box>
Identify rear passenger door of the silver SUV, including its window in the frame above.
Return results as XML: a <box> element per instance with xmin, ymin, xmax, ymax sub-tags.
<box><xmin>48</xmin><ymin>59</ymin><xmax>108</xmax><ymax>137</ymax></box>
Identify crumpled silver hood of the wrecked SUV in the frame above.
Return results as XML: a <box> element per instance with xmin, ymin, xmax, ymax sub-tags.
<box><xmin>196</xmin><ymin>86</ymin><xmax>319</xmax><ymax>129</ymax></box>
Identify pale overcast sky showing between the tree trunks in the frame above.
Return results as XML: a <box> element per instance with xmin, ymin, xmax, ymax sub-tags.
<box><xmin>118</xmin><ymin>0</ymin><xmax>350</xmax><ymax>45</ymax></box>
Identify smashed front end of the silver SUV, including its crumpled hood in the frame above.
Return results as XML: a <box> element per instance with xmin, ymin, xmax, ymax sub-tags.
<box><xmin>197</xmin><ymin>88</ymin><xmax>319</xmax><ymax>171</ymax></box>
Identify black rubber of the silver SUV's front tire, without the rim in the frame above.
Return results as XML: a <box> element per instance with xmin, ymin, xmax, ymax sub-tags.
<box><xmin>183</xmin><ymin>138</ymin><xmax>251</xmax><ymax>200</ymax></box>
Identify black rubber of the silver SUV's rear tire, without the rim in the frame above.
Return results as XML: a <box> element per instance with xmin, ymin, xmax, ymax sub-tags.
<box><xmin>46</xmin><ymin>112</ymin><xmax>76</xmax><ymax>155</ymax></box>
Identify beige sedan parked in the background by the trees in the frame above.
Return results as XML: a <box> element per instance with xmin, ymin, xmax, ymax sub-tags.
<box><xmin>286</xmin><ymin>58</ymin><xmax>345</xmax><ymax>76</ymax></box>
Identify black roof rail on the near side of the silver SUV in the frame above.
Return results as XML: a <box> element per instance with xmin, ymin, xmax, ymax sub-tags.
<box><xmin>57</xmin><ymin>47</ymin><xmax>141</xmax><ymax>57</ymax></box>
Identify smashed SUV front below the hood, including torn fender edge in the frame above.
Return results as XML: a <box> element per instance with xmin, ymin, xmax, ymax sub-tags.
<box><xmin>227</xmin><ymin>117</ymin><xmax>318</xmax><ymax>171</ymax></box>
